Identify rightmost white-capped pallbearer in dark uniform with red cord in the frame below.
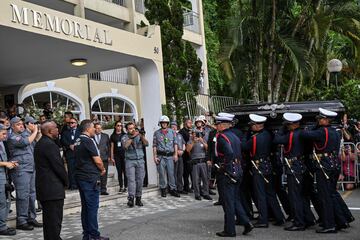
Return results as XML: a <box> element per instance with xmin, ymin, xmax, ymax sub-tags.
<box><xmin>302</xmin><ymin>108</ymin><xmax>348</xmax><ymax>233</ymax></box>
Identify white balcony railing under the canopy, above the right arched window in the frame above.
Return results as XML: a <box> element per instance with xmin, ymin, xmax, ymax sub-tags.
<box><xmin>88</xmin><ymin>68</ymin><xmax>130</xmax><ymax>84</ymax></box>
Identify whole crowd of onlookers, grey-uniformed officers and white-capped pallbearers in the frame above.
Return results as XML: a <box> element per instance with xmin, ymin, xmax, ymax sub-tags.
<box><xmin>0</xmin><ymin>106</ymin><xmax>360</xmax><ymax>240</ymax></box>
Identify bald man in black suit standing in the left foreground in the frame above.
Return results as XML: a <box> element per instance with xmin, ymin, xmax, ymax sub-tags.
<box><xmin>34</xmin><ymin>121</ymin><xmax>68</xmax><ymax>240</ymax></box>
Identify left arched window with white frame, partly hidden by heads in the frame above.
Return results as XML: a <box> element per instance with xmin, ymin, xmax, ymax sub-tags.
<box><xmin>23</xmin><ymin>92</ymin><xmax>81</xmax><ymax>119</ymax></box>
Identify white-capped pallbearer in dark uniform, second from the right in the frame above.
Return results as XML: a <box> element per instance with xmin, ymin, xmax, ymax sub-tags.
<box><xmin>273</xmin><ymin>113</ymin><xmax>315</xmax><ymax>231</ymax></box>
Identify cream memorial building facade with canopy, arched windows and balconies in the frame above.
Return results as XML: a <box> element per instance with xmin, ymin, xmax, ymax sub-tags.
<box><xmin>0</xmin><ymin>0</ymin><xmax>209</xmax><ymax>184</ymax></box>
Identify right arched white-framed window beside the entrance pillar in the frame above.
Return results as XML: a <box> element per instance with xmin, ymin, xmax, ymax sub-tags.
<box><xmin>91</xmin><ymin>97</ymin><xmax>135</xmax><ymax>123</ymax></box>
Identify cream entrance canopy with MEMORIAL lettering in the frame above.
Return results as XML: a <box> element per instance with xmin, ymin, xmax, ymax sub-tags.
<box><xmin>0</xmin><ymin>0</ymin><xmax>162</xmax><ymax>87</ymax></box>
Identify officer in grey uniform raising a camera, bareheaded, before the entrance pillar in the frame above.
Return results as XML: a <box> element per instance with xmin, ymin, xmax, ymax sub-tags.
<box><xmin>121</xmin><ymin>122</ymin><xmax>149</xmax><ymax>207</ymax></box>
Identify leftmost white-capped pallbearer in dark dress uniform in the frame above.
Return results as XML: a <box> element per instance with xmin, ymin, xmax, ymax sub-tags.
<box><xmin>215</xmin><ymin>116</ymin><xmax>253</xmax><ymax>237</ymax></box>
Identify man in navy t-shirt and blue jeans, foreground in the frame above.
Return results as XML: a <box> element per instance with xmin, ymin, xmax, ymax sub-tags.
<box><xmin>75</xmin><ymin>119</ymin><xmax>109</xmax><ymax>240</ymax></box>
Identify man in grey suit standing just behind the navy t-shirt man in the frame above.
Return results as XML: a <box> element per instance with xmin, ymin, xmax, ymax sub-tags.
<box><xmin>94</xmin><ymin>123</ymin><xmax>111</xmax><ymax>195</ymax></box>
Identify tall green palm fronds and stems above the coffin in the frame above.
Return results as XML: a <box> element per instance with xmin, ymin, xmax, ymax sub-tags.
<box><xmin>208</xmin><ymin>0</ymin><xmax>360</xmax><ymax>106</ymax></box>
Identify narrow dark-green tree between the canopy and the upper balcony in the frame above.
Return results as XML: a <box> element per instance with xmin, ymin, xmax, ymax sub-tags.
<box><xmin>145</xmin><ymin>0</ymin><xmax>202</xmax><ymax>120</ymax></box>
